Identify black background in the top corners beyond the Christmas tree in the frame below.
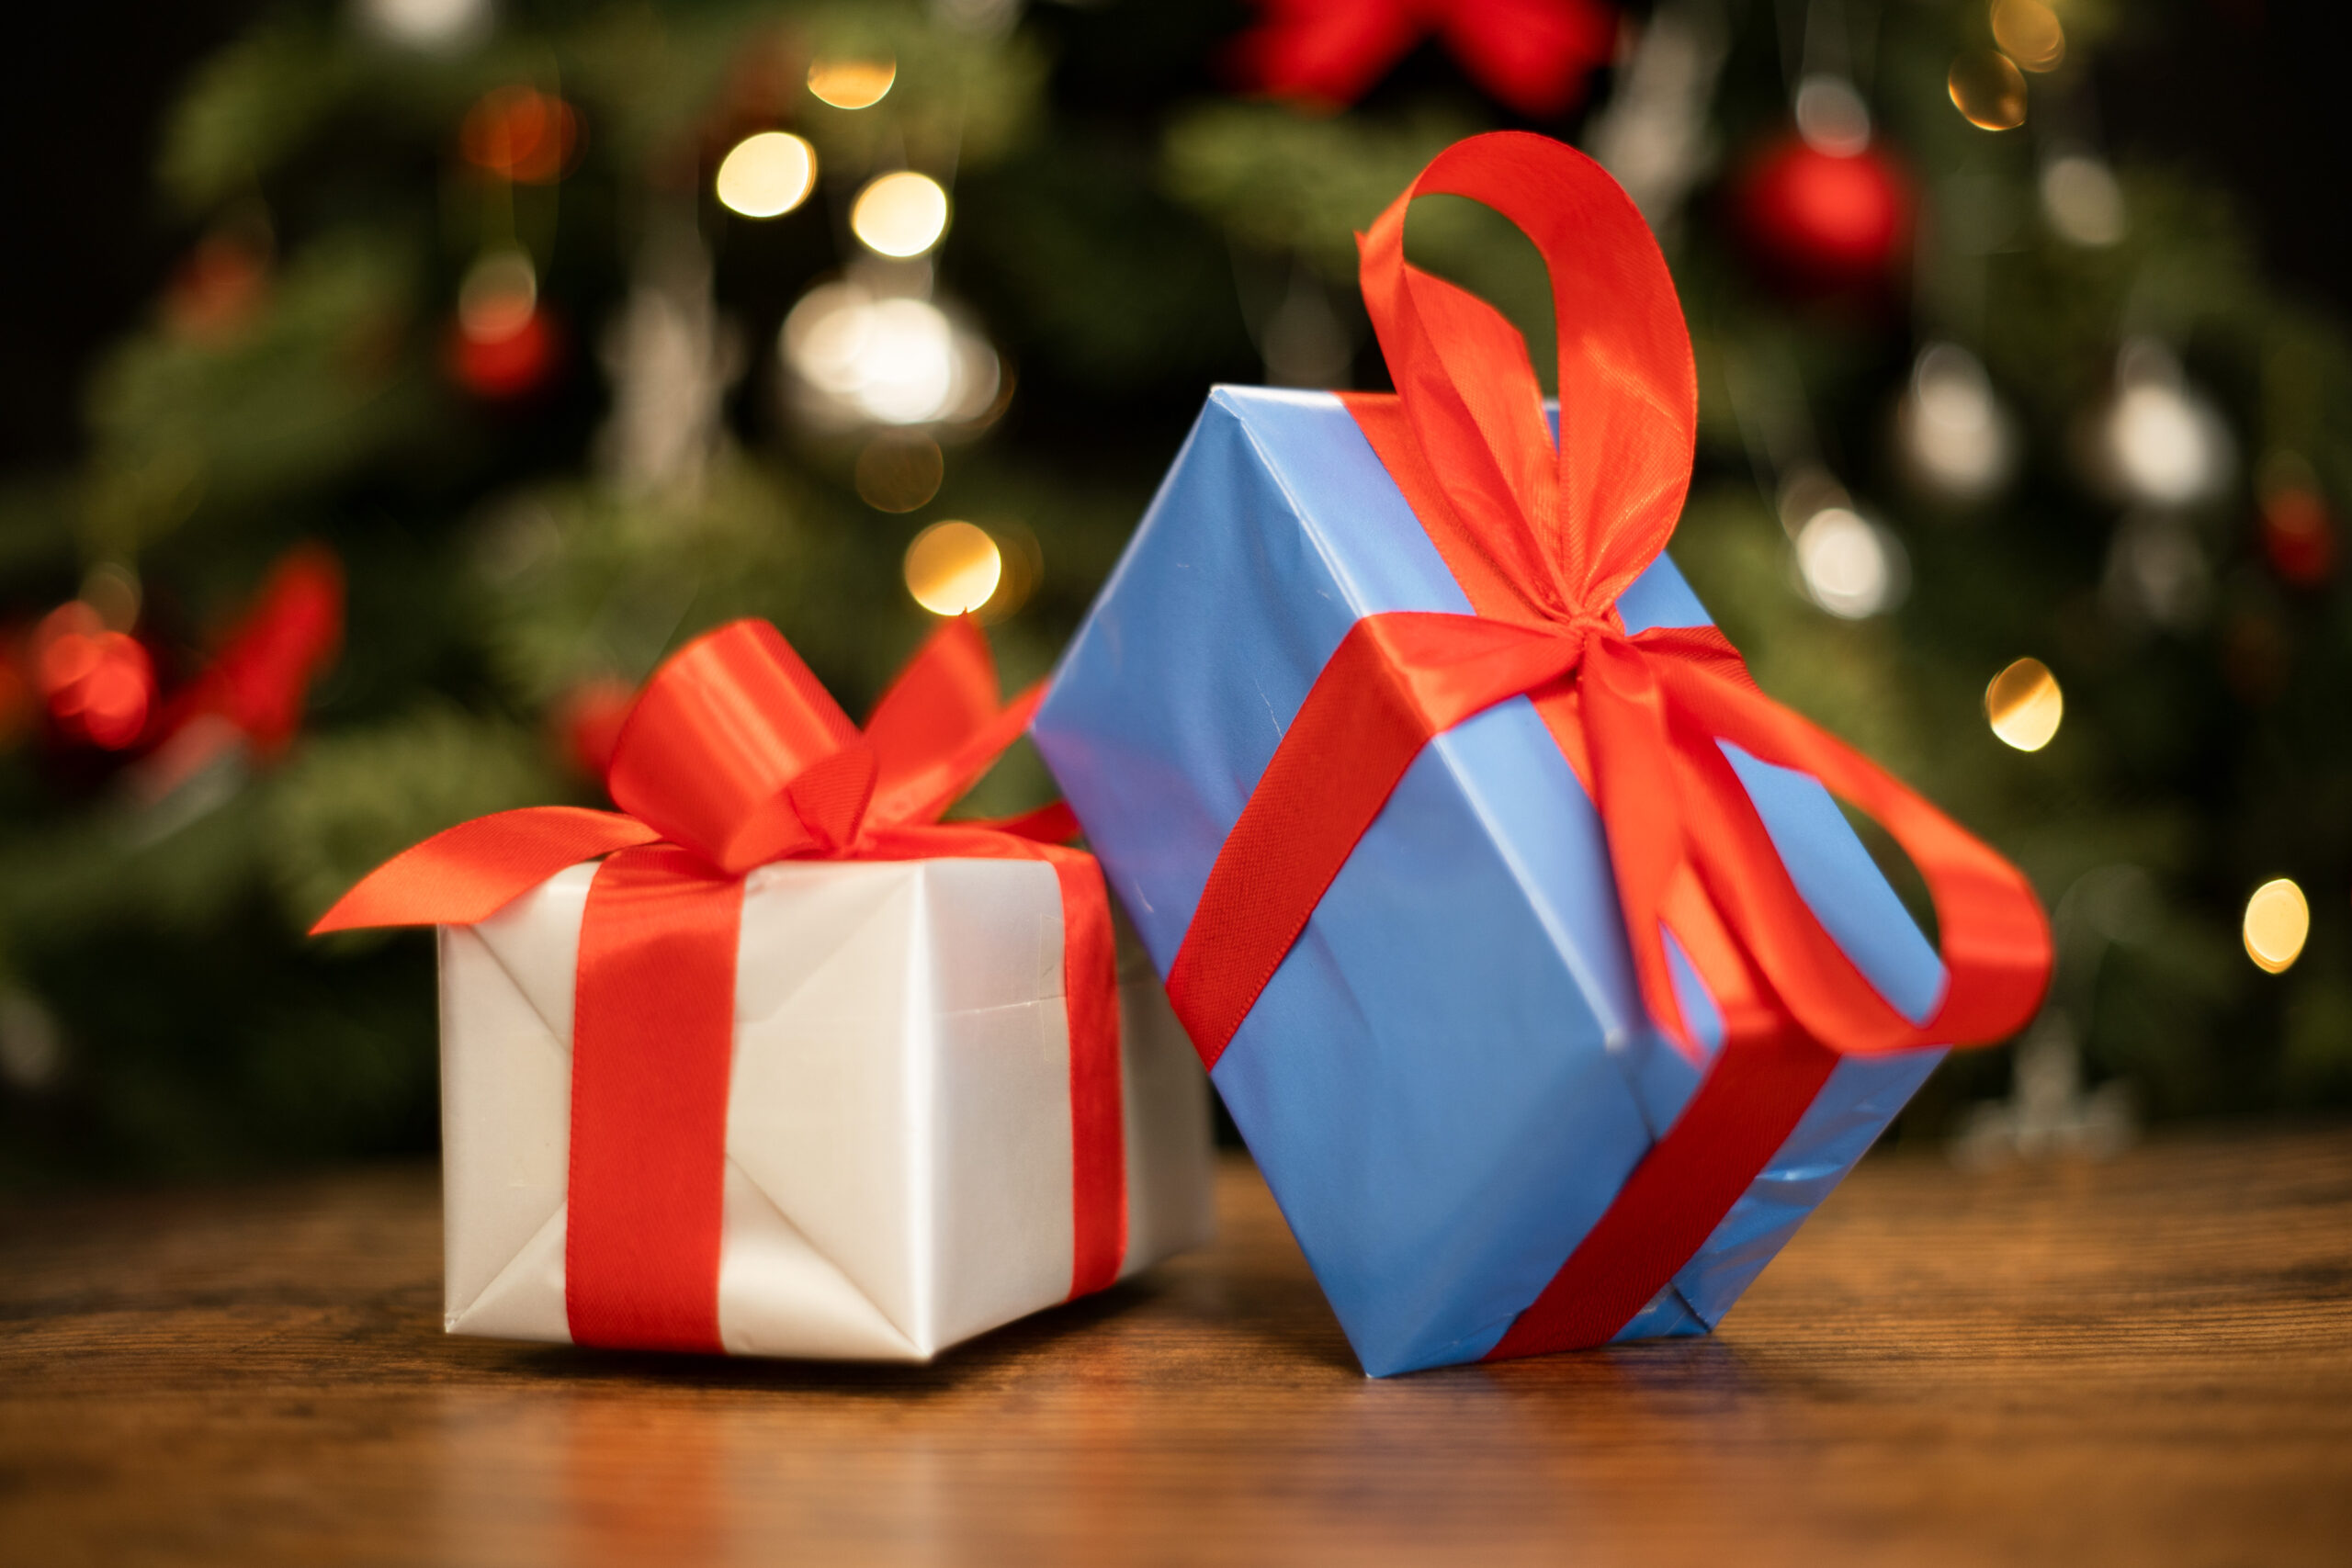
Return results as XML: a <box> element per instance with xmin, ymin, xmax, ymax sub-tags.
<box><xmin>0</xmin><ymin>0</ymin><xmax>2352</xmax><ymax>481</ymax></box>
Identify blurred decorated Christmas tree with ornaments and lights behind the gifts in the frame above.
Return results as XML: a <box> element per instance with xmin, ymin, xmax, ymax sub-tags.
<box><xmin>0</xmin><ymin>0</ymin><xmax>2352</xmax><ymax>1180</ymax></box>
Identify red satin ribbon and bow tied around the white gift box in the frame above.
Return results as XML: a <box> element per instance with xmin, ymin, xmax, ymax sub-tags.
<box><xmin>312</xmin><ymin>618</ymin><xmax>1126</xmax><ymax>1352</ymax></box>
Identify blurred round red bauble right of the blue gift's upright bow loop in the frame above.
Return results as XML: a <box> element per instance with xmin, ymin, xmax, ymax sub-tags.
<box><xmin>1731</xmin><ymin>136</ymin><xmax>1912</xmax><ymax>294</ymax></box>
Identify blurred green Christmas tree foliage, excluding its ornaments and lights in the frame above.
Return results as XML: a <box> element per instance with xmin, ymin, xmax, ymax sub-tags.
<box><xmin>0</xmin><ymin>0</ymin><xmax>2352</xmax><ymax>1182</ymax></box>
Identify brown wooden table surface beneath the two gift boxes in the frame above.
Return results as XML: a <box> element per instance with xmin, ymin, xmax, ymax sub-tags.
<box><xmin>0</xmin><ymin>1128</ymin><xmax>2352</xmax><ymax>1568</ymax></box>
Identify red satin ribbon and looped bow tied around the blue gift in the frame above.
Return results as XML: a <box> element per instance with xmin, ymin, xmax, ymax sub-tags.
<box><xmin>1169</xmin><ymin>131</ymin><xmax>2051</xmax><ymax>1359</ymax></box>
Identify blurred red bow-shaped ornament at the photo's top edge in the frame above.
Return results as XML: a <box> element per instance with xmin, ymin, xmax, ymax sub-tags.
<box><xmin>1230</xmin><ymin>0</ymin><xmax>1616</xmax><ymax>118</ymax></box>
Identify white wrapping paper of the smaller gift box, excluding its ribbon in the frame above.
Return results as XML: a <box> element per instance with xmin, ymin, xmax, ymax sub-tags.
<box><xmin>440</xmin><ymin>861</ymin><xmax>1214</xmax><ymax>1361</ymax></box>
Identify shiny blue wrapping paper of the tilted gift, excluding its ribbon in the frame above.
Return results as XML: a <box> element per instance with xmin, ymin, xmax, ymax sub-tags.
<box><xmin>1033</xmin><ymin>388</ymin><xmax>1943</xmax><ymax>1375</ymax></box>
